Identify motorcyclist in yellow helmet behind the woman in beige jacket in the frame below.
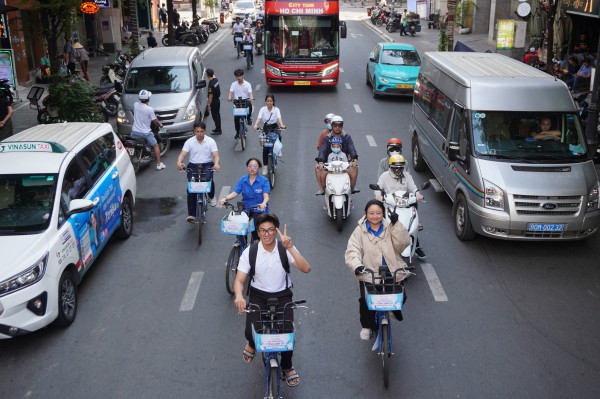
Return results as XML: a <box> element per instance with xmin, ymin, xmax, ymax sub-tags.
<box><xmin>375</xmin><ymin>154</ymin><xmax>427</xmax><ymax>260</ymax></box>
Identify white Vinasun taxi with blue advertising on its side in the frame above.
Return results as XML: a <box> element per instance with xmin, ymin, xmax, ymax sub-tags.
<box><xmin>0</xmin><ymin>123</ymin><xmax>136</xmax><ymax>339</ymax></box>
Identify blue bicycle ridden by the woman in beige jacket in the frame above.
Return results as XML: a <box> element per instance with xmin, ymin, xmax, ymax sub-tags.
<box><xmin>363</xmin><ymin>266</ymin><xmax>412</xmax><ymax>388</ymax></box>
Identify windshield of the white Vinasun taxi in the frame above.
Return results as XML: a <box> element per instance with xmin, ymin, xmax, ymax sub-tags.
<box><xmin>0</xmin><ymin>174</ymin><xmax>57</xmax><ymax>235</ymax></box>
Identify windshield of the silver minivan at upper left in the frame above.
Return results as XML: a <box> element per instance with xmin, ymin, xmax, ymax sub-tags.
<box><xmin>125</xmin><ymin>66</ymin><xmax>192</xmax><ymax>94</ymax></box>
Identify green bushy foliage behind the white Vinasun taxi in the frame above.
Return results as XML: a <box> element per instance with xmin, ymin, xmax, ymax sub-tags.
<box><xmin>48</xmin><ymin>80</ymin><xmax>104</xmax><ymax>122</ymax></box>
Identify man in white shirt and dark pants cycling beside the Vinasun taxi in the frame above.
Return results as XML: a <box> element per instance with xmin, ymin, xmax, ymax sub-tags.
<box><xmin>177</xmin><ymin>122</ymin><xmax>221</xmax><ymax>223</ymax></box>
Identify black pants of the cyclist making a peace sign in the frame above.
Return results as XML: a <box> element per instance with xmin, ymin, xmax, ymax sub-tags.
<box><xmin>245</xmin><ymin>288</ymin><xmax>294</xmax><ymax>370</ymax></box>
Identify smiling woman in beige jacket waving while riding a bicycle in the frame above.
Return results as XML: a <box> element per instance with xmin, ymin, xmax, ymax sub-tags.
<box><xmin>345</xmin><ymin>199</ymin><xmax>410</xmax><ymax>340</ymax></box>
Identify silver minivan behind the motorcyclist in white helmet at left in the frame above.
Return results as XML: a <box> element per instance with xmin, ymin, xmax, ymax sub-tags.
<box><xmin>117</xmin><ymin>46</ymin><xmax>208</xmax><ymax>138</ymax></box>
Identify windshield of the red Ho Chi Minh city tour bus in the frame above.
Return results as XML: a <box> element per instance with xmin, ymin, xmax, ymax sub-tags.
<box><xmin>264</xmin><ymin>15</ymin><xmax>339</xmax><ymax>59</ymax></box>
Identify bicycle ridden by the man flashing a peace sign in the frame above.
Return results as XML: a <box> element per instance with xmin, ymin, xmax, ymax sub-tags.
<box><xmin>245</xmin><ymin>298</ymin><xmax>307</xmax><ymax>399</ymax></box>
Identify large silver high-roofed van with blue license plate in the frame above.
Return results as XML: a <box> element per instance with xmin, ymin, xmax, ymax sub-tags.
<box><xmin>410</xmin><ymin>52</ymin><xmax>600</xmax><ymax>240</ymax></box>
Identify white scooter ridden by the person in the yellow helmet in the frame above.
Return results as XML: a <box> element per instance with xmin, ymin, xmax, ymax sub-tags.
<box><xmin>369</xmin><ymin>181</ymin><xmax>431</xmax><ymax>268</ymax></box>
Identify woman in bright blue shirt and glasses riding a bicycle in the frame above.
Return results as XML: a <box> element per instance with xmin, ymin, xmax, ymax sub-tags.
<box><xmin>219</xmin><ymin>158</ymin><xmax>271</xmax><ymax>240</ymax></box>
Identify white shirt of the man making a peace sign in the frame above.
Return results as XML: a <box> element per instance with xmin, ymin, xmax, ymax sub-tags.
<box><xmin>238</xmin><ymin>240</ymin><xmax>294</xmax><ymax>292</ymax></box>
